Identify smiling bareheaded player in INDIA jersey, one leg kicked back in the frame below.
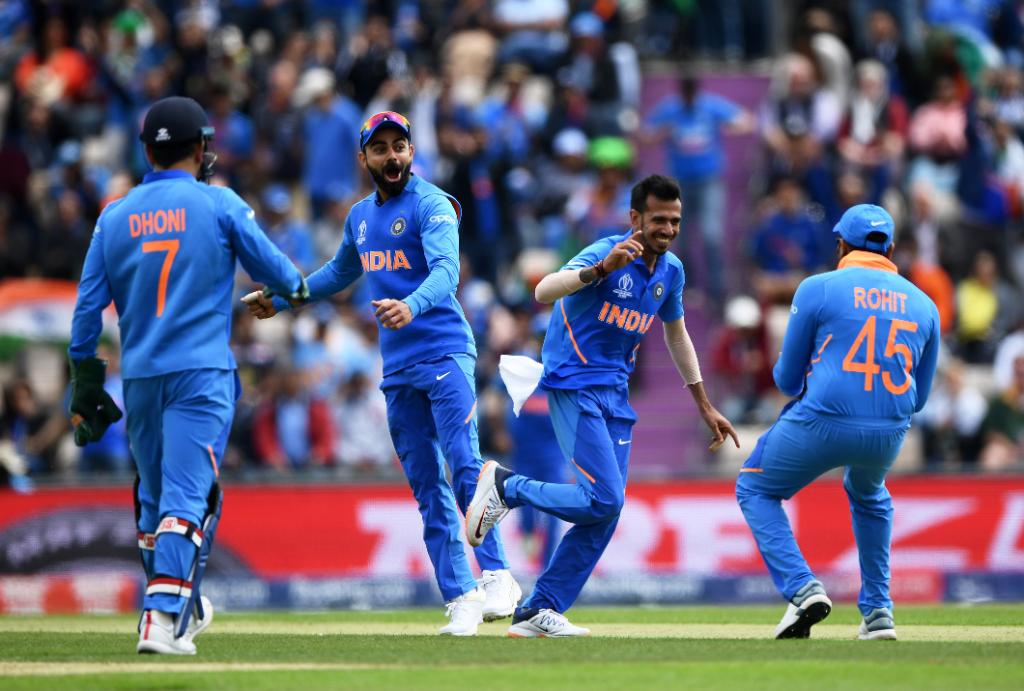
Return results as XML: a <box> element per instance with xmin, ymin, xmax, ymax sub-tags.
<box><xmin>466</xmin><ymin>175</ymin><xmax>739</xmax><ymax>638</ymax></box>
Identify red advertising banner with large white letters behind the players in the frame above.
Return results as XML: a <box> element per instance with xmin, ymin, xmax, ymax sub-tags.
<box><xmin>0</xmin><ymin>477</ymin><xmax>1024</xmax><ymax>578</ymax></box>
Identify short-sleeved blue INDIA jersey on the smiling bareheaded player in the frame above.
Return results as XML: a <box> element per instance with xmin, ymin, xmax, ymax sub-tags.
<box><xmin>541</xmin><ymin>230</ymin><xmax>685</xmax><ymax>389</ymax></box>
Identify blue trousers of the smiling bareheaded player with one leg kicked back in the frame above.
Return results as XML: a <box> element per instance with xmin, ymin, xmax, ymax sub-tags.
<box><xmin>505</xmin><ymin>386</ymin><xmax>636</xmax><ymax>612</ymax></box>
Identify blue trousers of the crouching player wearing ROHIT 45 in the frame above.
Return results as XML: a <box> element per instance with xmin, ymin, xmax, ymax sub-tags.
<box><xmin>736</xmin><ymin>409</ymin><xmax>906</xmax><ymax>614</ymax></box>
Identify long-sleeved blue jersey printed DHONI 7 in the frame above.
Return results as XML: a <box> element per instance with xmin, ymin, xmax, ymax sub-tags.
<box><xmin>69</xmin><ymin>170</ymin><xmax>302</xmax><ymax>379</ymax></box>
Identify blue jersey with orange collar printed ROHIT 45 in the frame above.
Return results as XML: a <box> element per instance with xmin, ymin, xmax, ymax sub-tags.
<box><xmin>773</xmin><ymin>251</ymin><xmax>940</xmax><ymax>428</ymax></box>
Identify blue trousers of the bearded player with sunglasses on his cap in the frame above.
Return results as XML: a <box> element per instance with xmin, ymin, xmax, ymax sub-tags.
<box><xmin>381</xmin><ymin>355</ymin><xmax>508</xmax><ymax>601</ymax></box>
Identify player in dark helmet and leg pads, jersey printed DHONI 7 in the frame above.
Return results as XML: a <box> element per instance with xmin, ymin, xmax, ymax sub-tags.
<box><xmin>69</xmin><ymin>96</ymin><xmax>306</xmax><ymax>655</ymax></box>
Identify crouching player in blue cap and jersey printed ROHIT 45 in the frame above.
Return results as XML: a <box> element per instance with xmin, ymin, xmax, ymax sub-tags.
<box><xmin>736</xmin><ymin>204</ymin><xmax>939</xmax><ymax>640</ymax></box>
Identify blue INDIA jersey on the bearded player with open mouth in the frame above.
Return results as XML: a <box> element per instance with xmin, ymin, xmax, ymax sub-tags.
<box><xmin>274</xmin><ymin>175</ymin><xmax>476</xmax><ymax>375</ymax></box>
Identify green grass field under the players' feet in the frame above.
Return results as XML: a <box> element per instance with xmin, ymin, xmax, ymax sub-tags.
<box><xmin>0</xmin><ymin>605</ymin><xmax>1024</xmax><ymax>691</ymax></box>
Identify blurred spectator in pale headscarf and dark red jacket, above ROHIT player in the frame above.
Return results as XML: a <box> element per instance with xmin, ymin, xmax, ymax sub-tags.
<box><xmin>837</xmin><ymin>60</ymin><xmax>908</xmax><ymax>200</ymax></box>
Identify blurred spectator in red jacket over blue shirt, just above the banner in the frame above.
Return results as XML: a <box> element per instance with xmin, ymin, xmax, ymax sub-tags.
<box><xmin>253</xmin><ymin>365</ymin><xmax>335</xmax><ymax>472</ymax></box>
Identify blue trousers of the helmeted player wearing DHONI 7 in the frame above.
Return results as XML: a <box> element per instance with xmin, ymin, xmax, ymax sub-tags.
<box><xmin>124</xmin><ymin>370</ymin><xmax>235</xmax><ymax>614</ymax></box>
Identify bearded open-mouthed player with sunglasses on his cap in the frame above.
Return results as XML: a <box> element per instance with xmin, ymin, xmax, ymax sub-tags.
<box><xmin>246</xmin><ymin>112</ymin><xmax>522</xmax><ymax>636</ymax></box>
